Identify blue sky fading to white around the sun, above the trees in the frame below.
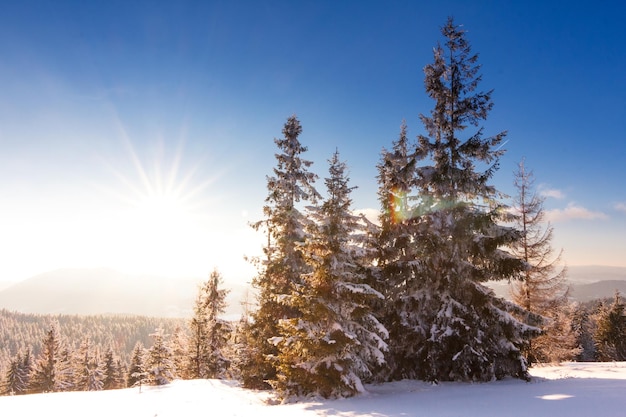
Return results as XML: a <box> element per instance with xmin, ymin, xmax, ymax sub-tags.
<box><xmin>0</xmin><ymin>1</ymin><xmax>626</xmax><ymax>282</ymax></box>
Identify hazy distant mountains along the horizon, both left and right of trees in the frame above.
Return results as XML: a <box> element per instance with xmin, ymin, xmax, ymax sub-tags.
<box><xmin>0</xmin><ymin>266</ymin><xmax>626</xmax><ymax>320</ymax></box>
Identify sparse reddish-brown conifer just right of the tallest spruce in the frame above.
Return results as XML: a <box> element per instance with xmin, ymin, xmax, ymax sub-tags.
<box><xmin>511</xmin><ymin>161</ymin><xmax>580</xmax><ymax>363</ymax></box>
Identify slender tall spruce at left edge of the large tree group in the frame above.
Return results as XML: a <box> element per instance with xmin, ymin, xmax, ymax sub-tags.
<box><xmin>241</xmin><ymin>115</ymin><xmax>319</xmax><ymax>388</ymax></box>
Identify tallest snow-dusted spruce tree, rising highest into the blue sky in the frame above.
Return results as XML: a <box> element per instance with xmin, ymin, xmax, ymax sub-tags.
<box><xmin>401</xmin><ymin>18</ymin><xmax>539</xmax><ymax>381</ymax></box>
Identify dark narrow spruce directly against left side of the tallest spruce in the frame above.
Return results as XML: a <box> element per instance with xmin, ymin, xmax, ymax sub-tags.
<box><xmin>372</xmin><ymin>121</ymin><xmax>423</xmax><ymax>380</ymax></box>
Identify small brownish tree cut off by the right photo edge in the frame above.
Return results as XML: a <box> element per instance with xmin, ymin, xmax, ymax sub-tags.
<box><xmin>594</xmin><ymin>291</ymin><xmax>626</xmax><ymax>361</ymax></box>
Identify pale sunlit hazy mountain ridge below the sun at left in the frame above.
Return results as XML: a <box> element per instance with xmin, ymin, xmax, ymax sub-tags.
<box><xmin>0</xmin><ymin>268</ymin><xmax>246</xmax><ymax>317</ymax></box>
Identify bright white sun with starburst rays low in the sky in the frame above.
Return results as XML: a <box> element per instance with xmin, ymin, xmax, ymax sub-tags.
<box><xmin>97</xmin><ymin>136</ymin><xmax>222</xmax><ymax>275</ymax></box>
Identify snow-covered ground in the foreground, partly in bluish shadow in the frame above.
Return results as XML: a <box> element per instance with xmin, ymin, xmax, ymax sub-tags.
<box><xmin>0</xmin><ymin>362</ymin><xmax>626</xmax><ymax>417</ymax></box>
